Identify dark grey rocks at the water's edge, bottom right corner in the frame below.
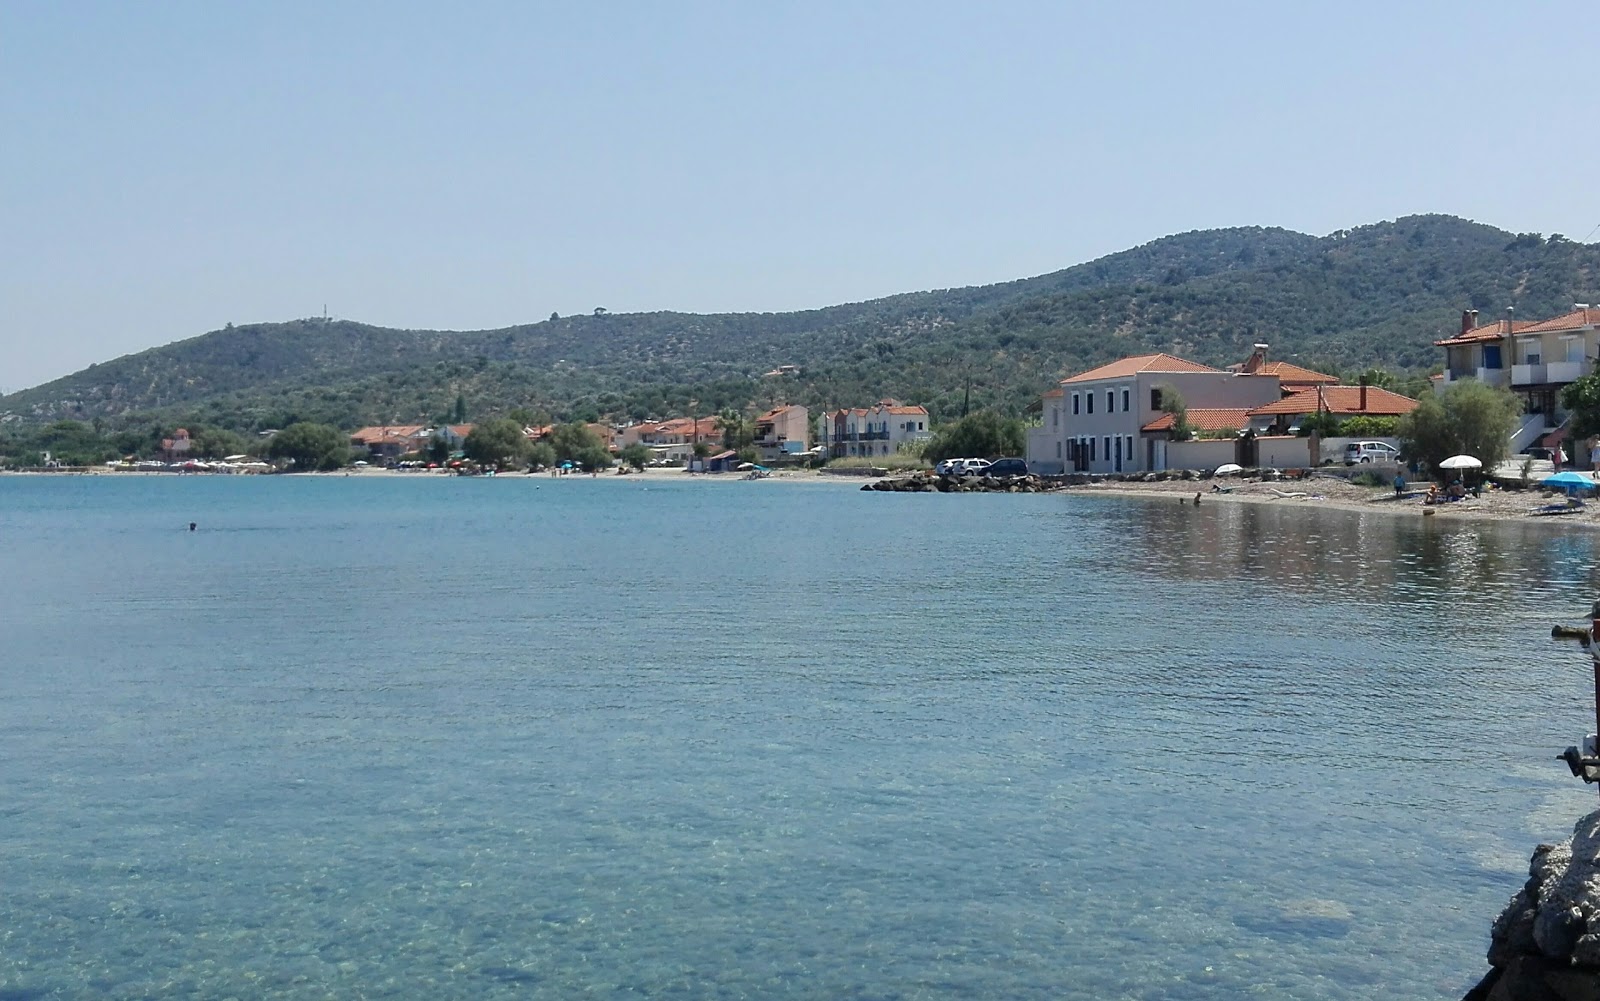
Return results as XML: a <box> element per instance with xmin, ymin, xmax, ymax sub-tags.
<box><xmin>1464</xmin><ymin>811</ymin><xmax>1600</xmax><ymax>1001</ymax></box>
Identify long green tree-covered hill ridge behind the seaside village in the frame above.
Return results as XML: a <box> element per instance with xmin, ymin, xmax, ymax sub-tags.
<box><xmin>0</xmin><ymin>216</ymin><xmax>1600</xmax><ymax>429</ymax></box>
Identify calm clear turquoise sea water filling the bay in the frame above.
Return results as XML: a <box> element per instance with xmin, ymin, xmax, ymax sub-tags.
<box><xmin>0</xmin><ymin>477</ymin><xmax>1600</xmax><ymax>1001</ymax></box>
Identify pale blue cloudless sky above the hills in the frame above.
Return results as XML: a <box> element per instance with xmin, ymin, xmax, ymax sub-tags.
<box><xmin>0</xmin><ymin>0</ymin><xmax>1600</xmax><ymax>392</ymax></box>
